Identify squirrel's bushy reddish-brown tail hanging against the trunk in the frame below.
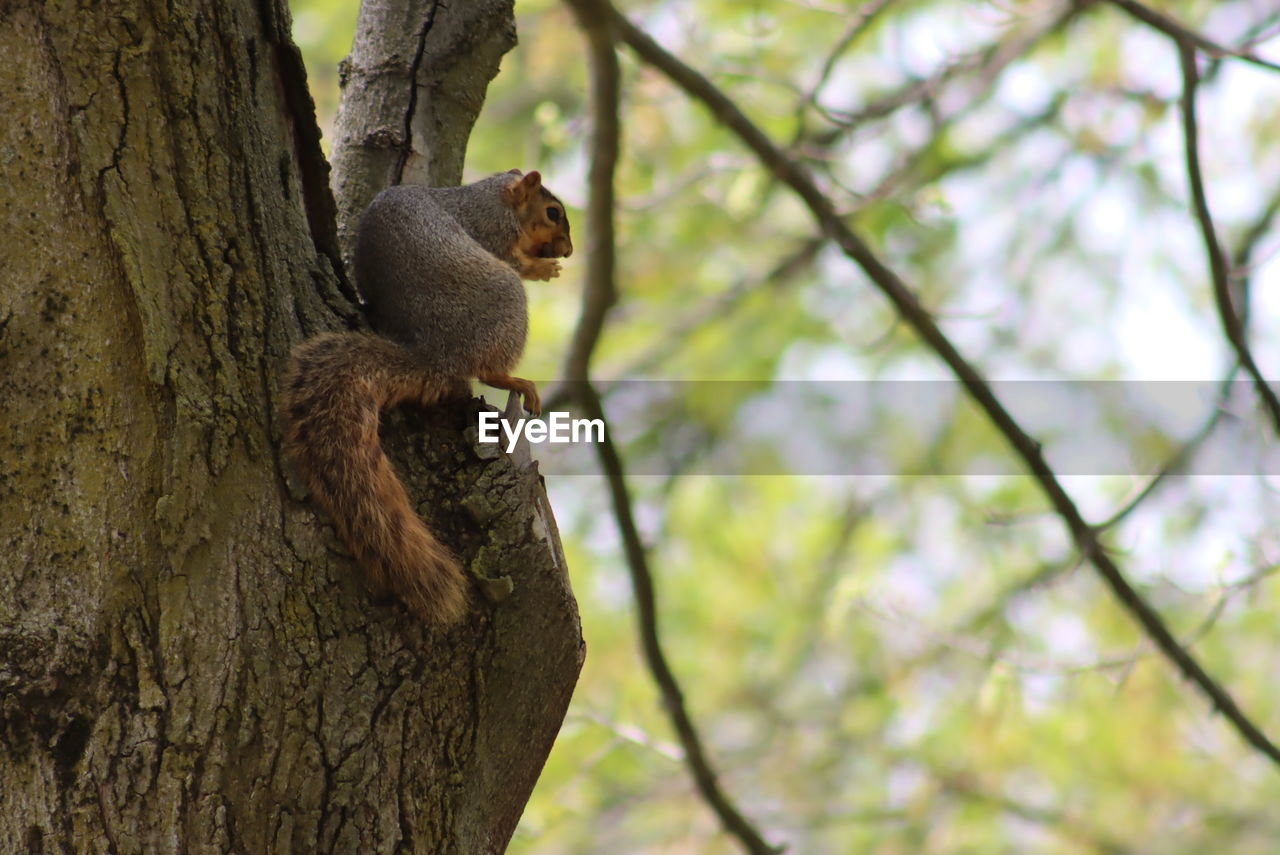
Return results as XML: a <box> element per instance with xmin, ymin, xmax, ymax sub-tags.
<box><xmin>283</xmin><ymin>333</ymin><xmax>467</xmax><ymax>626</ymax></box>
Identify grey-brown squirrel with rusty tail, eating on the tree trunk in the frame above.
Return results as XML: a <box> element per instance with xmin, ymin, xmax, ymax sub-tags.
<box><xmin>282</xmin><ymin>169</ymin><xmax>573</xmax><ymax>626</ymax></box>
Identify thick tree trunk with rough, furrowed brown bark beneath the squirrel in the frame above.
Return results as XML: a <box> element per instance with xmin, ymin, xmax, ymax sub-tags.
<box><xmin>0</xmin><ymin>0</ymin><xmax>581</xmax><ymax>855</ymax></box>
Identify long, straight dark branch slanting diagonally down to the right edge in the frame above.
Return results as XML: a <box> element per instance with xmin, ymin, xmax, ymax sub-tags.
<box><xmin>604</xmin><ymin>0</ymin><xmax>1280</xmax><ymax>765</ymax></box>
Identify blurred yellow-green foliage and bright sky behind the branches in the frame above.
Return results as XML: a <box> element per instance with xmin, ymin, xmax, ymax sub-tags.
<box><xmin>293</xmin><ymin>0</ymin><xmax>1280</xmax><ymax>855</ymax></box>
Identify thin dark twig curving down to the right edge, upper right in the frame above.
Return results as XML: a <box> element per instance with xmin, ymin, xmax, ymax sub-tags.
<box><xmin>1178</xmin><ymin>41</ymin><xmax>1280</xmax><ymax>433</ymax></box>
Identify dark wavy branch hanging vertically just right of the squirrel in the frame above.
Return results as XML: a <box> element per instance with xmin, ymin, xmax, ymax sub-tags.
<box><xmin>564</xmin><ymin>0</ymin><xmax>782</xmax><ymax>855</ymax></box>
